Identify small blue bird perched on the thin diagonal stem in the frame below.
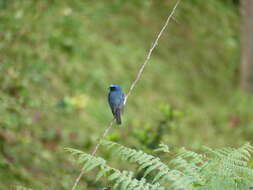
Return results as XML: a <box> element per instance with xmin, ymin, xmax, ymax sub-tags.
<box><xmin>108</xmin><ymin>84</ymin><xmax>125</xmax><ymax>125</ymax></box>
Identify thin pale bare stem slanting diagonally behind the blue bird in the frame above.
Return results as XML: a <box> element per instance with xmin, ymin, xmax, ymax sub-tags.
<box><xmin>72</xmin><ymin>0</ymin><xmax>180</xmax><ymax>190</ymax></box>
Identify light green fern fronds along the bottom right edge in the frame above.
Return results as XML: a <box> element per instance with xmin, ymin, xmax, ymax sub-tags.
<box><xmin>68</xmin><ymin>141</ymin><xmax>253</xmax><ymax>190</ymax></box>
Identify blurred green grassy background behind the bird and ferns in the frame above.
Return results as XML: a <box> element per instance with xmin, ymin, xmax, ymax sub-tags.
<box><xmin>0</xmin><ymin>0</ymin><xmax>253</xmax><ymax>190</ymax></box>
